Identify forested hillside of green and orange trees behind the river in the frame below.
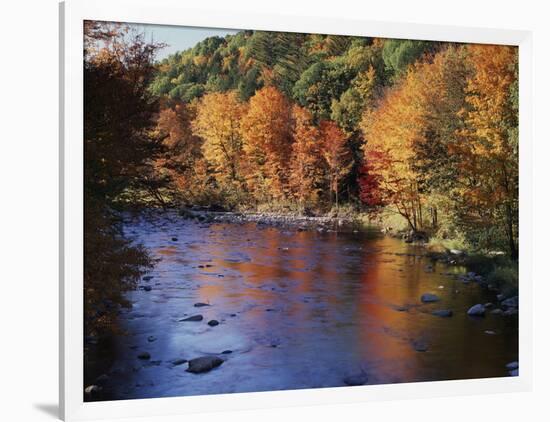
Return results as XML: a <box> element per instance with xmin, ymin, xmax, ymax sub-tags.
<box><xmin>151</xmin><ymin>31</ymin><xmax>518</xmax><ymax>255</ymax></box>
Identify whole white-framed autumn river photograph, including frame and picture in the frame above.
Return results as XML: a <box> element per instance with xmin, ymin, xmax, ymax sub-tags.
<box><xmin>60</xmin><ymin>0</ymin><xmax>532</xmax><ymax>421</ymax></box>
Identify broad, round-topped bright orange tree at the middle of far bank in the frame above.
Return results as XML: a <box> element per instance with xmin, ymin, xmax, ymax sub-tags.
<box><xmin>241</xmin><ymin>86</ymin><xmax>292</xmax><ymax>200</ymax></box>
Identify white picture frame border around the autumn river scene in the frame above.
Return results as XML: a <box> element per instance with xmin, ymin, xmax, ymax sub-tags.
<box><xmin>60</xmin><ymin>0</ymin><xmax>533</xmax><ymax>421</ymax></box>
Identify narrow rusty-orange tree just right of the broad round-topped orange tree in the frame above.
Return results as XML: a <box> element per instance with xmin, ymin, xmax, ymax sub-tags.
<box><xmin>289</xmin><ymin>105</ymin><xmax>323</xmax><ymax>211</ymax></box>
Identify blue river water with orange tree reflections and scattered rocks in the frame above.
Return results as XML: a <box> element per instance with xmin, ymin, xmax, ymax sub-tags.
<box><xmin>88</xmin><ymin>214</ymin><xmax>518</xmax><ymax>400</ymax></box>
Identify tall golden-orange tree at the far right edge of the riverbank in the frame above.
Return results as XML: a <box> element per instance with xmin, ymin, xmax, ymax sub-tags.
<box><xmin>451</xmin><ymin>45</ymin><xmax>519</xmax><ymax>257</ymax></box>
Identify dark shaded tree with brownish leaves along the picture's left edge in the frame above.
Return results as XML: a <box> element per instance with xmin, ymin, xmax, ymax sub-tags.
<box><xmin>84</xmin><ymin>21</ymin><xmax>165</xmax><ymax>335</ymax></box>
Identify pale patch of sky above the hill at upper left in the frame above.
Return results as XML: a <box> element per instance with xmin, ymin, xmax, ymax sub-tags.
<box><xmin>130</xmin><ymin>24</ymin><xmax>239</xmax><ymax>60</ymax></box>
